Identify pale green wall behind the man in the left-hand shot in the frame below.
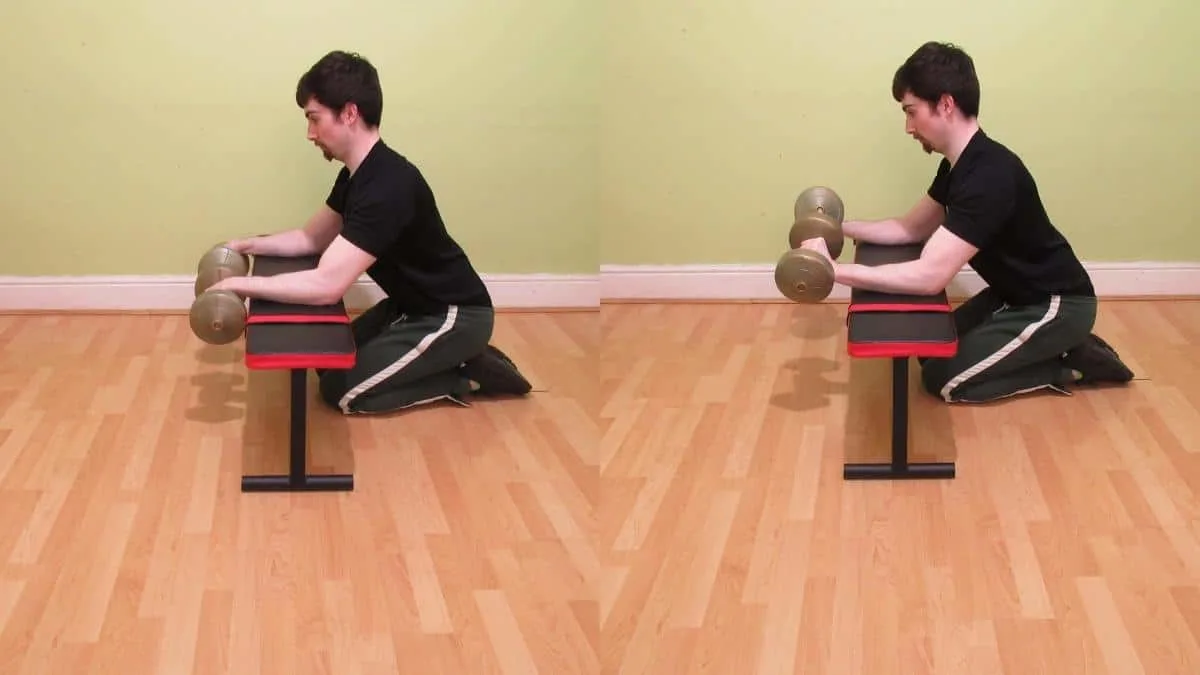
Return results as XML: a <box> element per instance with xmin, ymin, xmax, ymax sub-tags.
<box><xmin>0</xmin><ymin>0</ymin><xmax>600</xmax><ymax>275</ymax></box>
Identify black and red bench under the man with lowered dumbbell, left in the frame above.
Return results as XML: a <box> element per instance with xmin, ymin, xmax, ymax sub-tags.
<box><xmin>241</xmin><ymin>256</ymin><xmax>355</xmax><ymax>492</ymax></box>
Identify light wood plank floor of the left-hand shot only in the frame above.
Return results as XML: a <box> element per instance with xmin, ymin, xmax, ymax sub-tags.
<box><xmin>0</xmin><ymin>312</ymin><xmax>600</xmax><ymax>675</ymax></box>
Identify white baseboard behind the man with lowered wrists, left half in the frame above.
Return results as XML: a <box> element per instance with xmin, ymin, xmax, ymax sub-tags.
<box><xmin>0</xmin><ymin>274</ymin><xmax>600</xmax><ymax>312</ymax></box>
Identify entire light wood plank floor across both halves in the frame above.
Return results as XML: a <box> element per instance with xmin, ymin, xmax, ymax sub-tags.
<box><xmin>0</xmin><ymin>301</ymin><xmax>1200</xmax><ymax>675</ymax></box>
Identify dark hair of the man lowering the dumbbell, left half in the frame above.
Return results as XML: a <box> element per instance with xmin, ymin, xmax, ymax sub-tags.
<box><xmin>296</xmin><ymin>50</ymin><xmax>383</xmax><ymax>127</ymax></box>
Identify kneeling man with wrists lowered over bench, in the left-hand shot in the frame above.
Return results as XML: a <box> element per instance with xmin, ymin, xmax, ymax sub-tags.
<box><xmin>214</xmin><ymin>52</ymin><xmax>530</xmax><ymax>414</ymax></box>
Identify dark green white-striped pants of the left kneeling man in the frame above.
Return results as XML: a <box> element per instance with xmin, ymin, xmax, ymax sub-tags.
<box><xmin>318</xmin><ymin>299</ymin><xmax>496</xmax><ymax>414</ymax></box>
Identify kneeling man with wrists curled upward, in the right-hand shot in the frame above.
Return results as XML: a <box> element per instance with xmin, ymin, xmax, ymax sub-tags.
<box><xmin>804</xmin><ymin>42</ymin><xmax>1133</xmax><ymax>402</ymax></box>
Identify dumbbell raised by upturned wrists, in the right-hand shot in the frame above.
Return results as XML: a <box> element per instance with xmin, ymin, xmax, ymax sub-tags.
<box><xmin>775</xmin><ymin>186</ymin><xmax>845</xmax><ymax>303</ymax></box>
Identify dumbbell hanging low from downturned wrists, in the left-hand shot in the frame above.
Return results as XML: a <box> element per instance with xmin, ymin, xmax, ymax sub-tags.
<box><xmin>188</xmin><ymin>244</ymin><xmax>250</xmax><ymax>345</ymax></box>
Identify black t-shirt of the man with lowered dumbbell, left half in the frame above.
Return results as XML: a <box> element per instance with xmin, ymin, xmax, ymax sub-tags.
<box><xmin>325</xmin><ymin>141</ymin><xmax>492</xmax><ymax>313</ymax></box>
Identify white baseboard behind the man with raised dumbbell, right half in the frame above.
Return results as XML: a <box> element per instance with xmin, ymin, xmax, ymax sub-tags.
<box><xmin>600</xmin><ymin>262</ymin><xmax>1200</xmax><ymax>303</ymax></box>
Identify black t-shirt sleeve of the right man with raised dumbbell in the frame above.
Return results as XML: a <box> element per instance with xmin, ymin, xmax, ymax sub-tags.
<box><xmin>943</xmin><ymin>165</ymin><xmax>1016</xmax><ymax>249</ymax></box>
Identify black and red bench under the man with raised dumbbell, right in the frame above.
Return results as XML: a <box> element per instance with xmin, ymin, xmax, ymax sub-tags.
<box><xmin>842</xmin><ymin>243</ymin><xmax>958</xmax><ymax>480</ymax></box>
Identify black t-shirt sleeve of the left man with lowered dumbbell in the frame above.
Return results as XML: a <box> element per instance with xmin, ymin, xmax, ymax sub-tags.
<box><xmin>342</xmin><ymin>171</ymin><xmax>416</xmax><ymax>258</ymax></box>
